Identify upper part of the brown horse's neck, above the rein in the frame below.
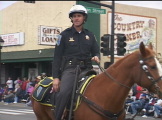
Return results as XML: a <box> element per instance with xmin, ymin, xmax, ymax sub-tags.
<box><xmin>106</xmin><ymin>52</ymin><xmax>140</xmax><ymax>87</ymax></box>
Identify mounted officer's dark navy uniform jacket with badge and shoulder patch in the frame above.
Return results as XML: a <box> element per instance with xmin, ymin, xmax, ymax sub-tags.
<box><xmin>53</xmin><ymin>26</ymin><xmax>100</xmax><ymax>78</ymax></box>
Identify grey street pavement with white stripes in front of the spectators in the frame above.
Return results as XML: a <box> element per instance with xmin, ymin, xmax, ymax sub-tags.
<box><xmin>0</xmin><ymin>102</ymin><xmax>162</xmax><ymax>120</ymax></box>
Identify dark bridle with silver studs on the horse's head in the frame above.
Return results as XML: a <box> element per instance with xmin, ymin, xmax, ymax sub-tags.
<box><xmin>139</xmin><ymin>56</ymin><xmax>162</xmax><ymax>92</ymax></box>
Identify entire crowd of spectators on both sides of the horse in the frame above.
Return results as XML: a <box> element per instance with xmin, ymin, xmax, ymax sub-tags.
<box><xmin>0</xmin><ymin>73</ymin><xmax>162</xmax><ymax>118</ymax></box>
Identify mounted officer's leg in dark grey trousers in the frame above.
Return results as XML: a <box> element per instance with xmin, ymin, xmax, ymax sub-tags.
<box><xmin>55</xmin><ymin>68</ymin><xmax>75</xmax><ymax>120</ymax></box>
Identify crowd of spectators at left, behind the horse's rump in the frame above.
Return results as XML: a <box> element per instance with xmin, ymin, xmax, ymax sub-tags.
<box><xmin>0</xmin><ymin>73</ymin><xmax>46</xmax><ymax>106</ymax></box>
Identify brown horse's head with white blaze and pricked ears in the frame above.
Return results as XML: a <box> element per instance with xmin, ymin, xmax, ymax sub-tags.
<box><xmin>137</xmin><ymin>42</ymin><xmax>162</xmax><ymax>97</ymax></box>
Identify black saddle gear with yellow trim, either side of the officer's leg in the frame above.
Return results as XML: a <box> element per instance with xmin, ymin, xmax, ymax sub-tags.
<box><xmin>32</xmin><ymin>70</ymin><xmax>97</xmax><ymax>111</ymax></box>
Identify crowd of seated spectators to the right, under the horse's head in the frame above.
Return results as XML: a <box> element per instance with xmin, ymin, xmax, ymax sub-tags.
<box><xmin>125</xmin><ymin>84</ymin><xmax>162</xmax><ymax>118</ymax></box>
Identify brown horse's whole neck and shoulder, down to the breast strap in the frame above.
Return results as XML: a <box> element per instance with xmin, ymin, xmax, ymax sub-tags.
<box><xmin>84</xmin><ymin>54</ymin><xmax>139</xmax><ymax>112</ymax></box>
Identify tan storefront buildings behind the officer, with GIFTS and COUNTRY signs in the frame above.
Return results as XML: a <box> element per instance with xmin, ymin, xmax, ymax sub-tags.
<box><xmin>0</xmin><ymin>1</ymin><xmax>162</xmax><ymax>84</ymax></box>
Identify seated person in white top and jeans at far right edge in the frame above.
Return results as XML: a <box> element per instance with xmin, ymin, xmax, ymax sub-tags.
<box><xmin>154</xmin><ymin>99</ymin><xmax>162</xmax><ymax>118</ymax></box>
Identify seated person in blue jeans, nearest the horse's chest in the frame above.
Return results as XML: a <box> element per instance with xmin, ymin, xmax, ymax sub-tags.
<box><xmin>130</xmin><ymin>93</ymin><xmax>149</xmax><ymax>115</ymax></box>
